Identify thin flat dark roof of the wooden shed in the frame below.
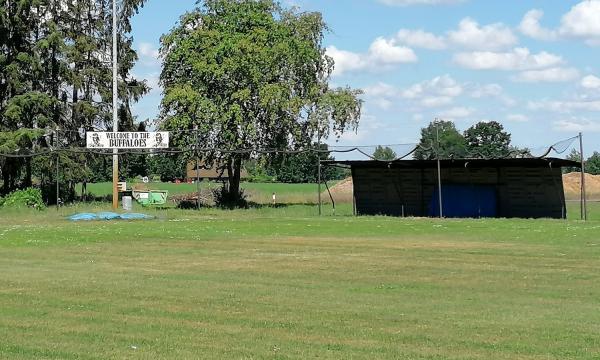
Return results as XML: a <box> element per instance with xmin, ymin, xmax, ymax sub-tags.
<box><xmin>322</xmin><ymin>158</ymin><xmax>581</xmax><ymax>169</ymax></box>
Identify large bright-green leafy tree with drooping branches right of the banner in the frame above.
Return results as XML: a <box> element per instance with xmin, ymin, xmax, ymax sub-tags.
<box><xmin>160</xmin><ymin>0</ymin><xmax>361</xmax><ymax>200</ymax></box>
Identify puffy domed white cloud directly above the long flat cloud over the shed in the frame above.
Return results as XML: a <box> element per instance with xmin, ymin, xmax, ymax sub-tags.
<box><xmin>448</xmin><ymin>18</ymin><xmax>518</xmax><ymax>50</ymax></box>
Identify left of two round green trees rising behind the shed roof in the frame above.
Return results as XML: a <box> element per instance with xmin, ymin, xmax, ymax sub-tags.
<box><xmin>415</xmin><ymin>120</ymin><xmax>468</xmax><ymax>160</ymax></box>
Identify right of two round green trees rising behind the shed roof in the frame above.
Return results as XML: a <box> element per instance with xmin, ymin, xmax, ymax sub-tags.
<box><xmin>464</xmin><ymin>121</ymin><xmax>511</xmax><ymax>159</ymax></box>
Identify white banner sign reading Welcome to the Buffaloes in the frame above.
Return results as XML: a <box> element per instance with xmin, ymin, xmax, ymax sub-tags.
<box><xmin>86</xmin><ymin>131</ymin><xmax>169</xmax><ymax>149</ymax></box>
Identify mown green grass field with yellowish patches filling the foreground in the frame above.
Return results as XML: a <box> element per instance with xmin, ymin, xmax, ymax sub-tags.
<box><xmin>0</xmin><ymin>204</ymin><xmax>600</xmax><ymax>359</ymax></box>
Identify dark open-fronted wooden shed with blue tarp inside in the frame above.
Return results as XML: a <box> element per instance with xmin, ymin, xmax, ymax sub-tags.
<box><xmin>324</xmin><ymin>158</ymin><xmax>579</xmax><ymax>219</ymax></box>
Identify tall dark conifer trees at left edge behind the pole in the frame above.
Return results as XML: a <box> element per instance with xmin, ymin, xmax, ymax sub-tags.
<box><xmin>0</xmin><ymin>0</ymin><xmax>149</xmax><ymax>198</ymax></box>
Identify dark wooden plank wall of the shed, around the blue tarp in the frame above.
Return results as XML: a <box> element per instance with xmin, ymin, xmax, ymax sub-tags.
<box><xmin>352</xmin><ymin>167</ymin><xmax>566</xmax><ymax>218</ymax></box>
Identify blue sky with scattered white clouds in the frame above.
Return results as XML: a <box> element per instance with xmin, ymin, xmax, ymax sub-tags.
<box><xmin>133</xmin><ymin>0</ymin><xmax>600</xmax><ymax>152</ymax></box>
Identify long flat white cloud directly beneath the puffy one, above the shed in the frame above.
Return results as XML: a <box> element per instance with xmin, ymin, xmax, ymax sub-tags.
<box><xmin>453</xmin><ymin>48</ymin><xmax>564</xmax><ymax>71</ymax></box>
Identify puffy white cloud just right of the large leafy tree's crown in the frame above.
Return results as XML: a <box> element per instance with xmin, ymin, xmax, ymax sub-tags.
<box><xmin>327</xmin><ymin>37</ymin><xmax>418</xmax><ymax>75</ymax></box>
